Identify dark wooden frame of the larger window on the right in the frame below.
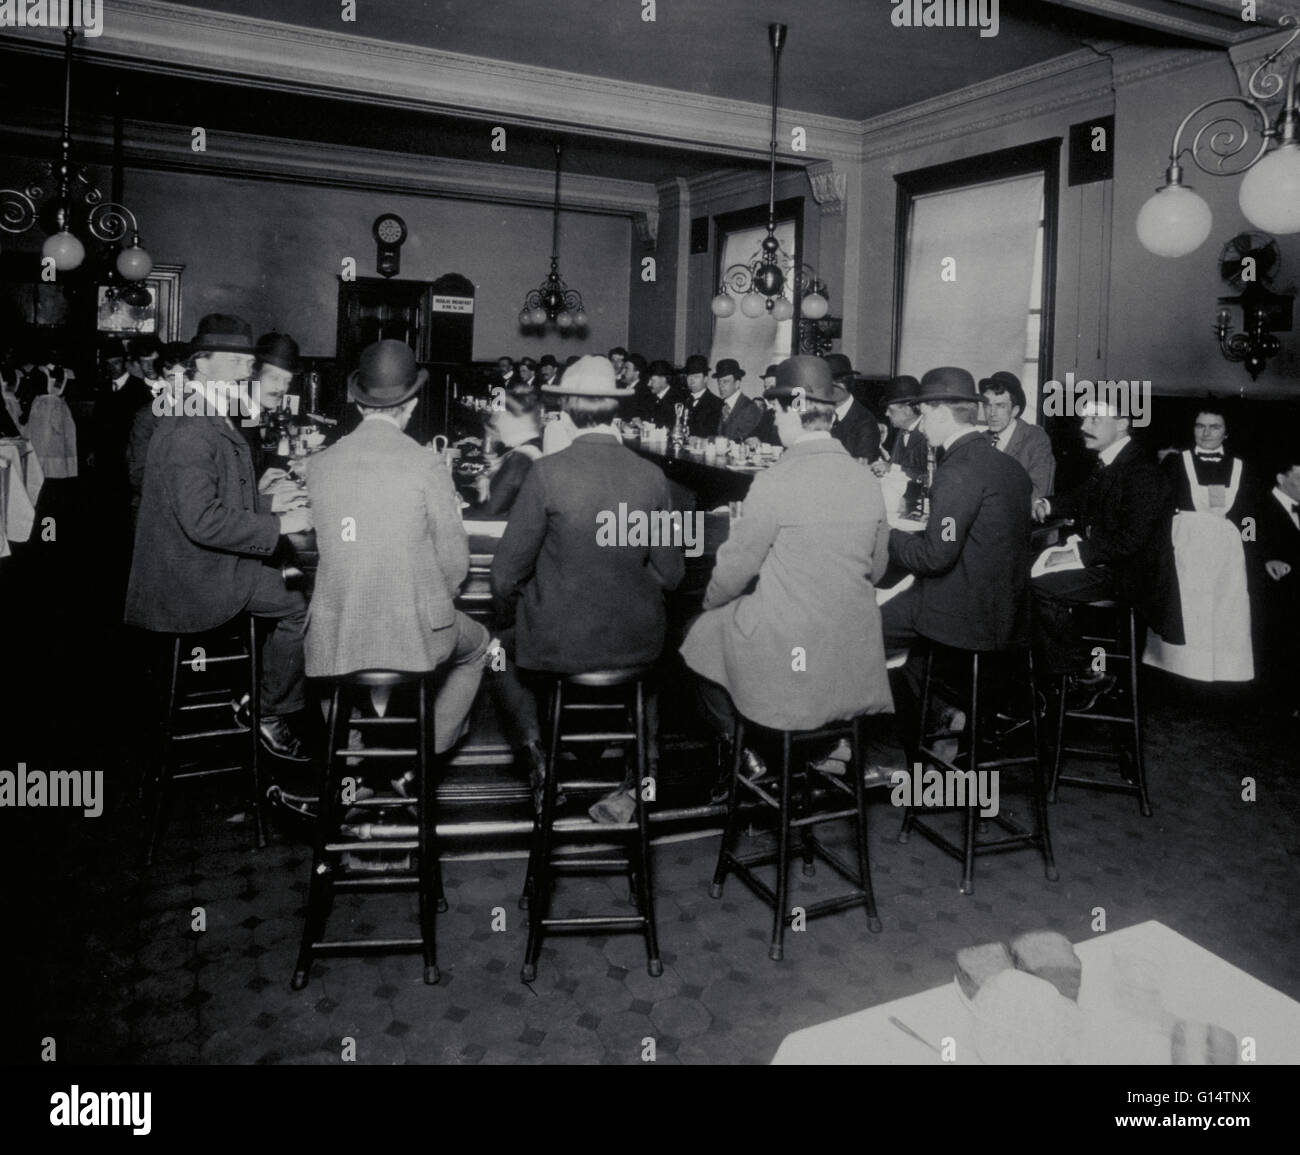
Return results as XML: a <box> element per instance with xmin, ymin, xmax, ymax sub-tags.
<box><xmin>889</xmin><ymin>137</ymin><xmax>1062</xmax><ymax>381</ymax></box>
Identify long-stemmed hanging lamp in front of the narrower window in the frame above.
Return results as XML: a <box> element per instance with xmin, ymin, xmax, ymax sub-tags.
<box><xmin>710</xmin><ymin>23</ymin><xmax>829</xmax><ymax>321</ymax></box>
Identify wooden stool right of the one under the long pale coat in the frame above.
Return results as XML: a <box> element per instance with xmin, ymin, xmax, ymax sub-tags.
<box><xmin>898</xmin><ymin>646</ymin><xmax>1061</xmax><ymax>895</ymax></box>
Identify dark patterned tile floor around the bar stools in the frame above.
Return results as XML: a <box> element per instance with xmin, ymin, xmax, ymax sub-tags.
<box><xmin>0</xmin><ymin>478</ymin><xmax>1300</xmax><ymax>1064</ymax></box>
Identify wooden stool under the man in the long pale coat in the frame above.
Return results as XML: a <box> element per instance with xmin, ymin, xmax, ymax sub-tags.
<box><xmin>709</xmin><ymin>715</ymin><xmax>880</xmax><ymax>961</ymax></box>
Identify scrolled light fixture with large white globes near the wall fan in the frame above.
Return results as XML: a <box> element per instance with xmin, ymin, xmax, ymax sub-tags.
<box><xmin>1138</xmin><ymin>13</ymin><xmax>1300</xmax><ymax>256</ymax></box>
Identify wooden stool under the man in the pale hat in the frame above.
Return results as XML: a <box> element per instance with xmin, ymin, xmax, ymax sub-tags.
<box><xmin>520</xmin><ymin>666</ymin><xmax>663</xmax><ymax>982</ymax></box>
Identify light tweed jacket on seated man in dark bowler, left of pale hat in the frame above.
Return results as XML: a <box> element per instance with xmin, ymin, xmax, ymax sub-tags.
<box><xmin>304</xmin><ymin>418</ymin><xmax>469</xmax><ymax>678</ymax></box>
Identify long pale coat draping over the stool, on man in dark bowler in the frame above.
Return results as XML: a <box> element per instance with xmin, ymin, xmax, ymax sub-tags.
<box><xmin>681</xmin><ymin>437</ymin><xmax>893</xmax><ymax>730</ymax></box>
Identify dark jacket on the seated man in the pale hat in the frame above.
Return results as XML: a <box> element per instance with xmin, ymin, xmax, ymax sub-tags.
<box><xmin>491</xmin><ymin>433</ymin><xmax>685</xmax><ymax>674</ymax></box>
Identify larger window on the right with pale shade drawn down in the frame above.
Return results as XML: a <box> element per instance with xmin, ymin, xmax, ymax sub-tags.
<box><xmin>896</xmin><ymin>153</ymin><xmax>1056</xmax><ymax>420</ymax></box>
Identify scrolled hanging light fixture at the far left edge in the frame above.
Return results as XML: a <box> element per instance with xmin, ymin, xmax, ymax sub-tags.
<box><xmin>0</xmin><ymin>23</ymin><xmax>153</xmax><ymax>281</ymax></box>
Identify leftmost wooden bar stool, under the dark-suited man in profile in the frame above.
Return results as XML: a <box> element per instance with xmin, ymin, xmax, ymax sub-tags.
<box><xmin>142</xmin><ymin>614</ymin><xmax>267</xmax><ymax>866</ymax></box>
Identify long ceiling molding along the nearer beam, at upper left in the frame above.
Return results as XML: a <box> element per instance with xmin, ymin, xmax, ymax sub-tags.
<box><xmin>5</xmin><ymin>0</ymin><xmax>858</xmax><ymax>159</ymax></box>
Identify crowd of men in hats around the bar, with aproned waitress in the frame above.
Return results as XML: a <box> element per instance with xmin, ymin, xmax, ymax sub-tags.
<box><xmin>63</xmin><ymin>315</ymin><xmax>1300</xmax><ymax>821</ymax></box>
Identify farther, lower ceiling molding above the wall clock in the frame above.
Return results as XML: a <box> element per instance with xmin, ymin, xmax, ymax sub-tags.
<box><xmin>0</xmin><ymin>113</ymin><xmax>659</xmax><ymax>219</ymax></box>
